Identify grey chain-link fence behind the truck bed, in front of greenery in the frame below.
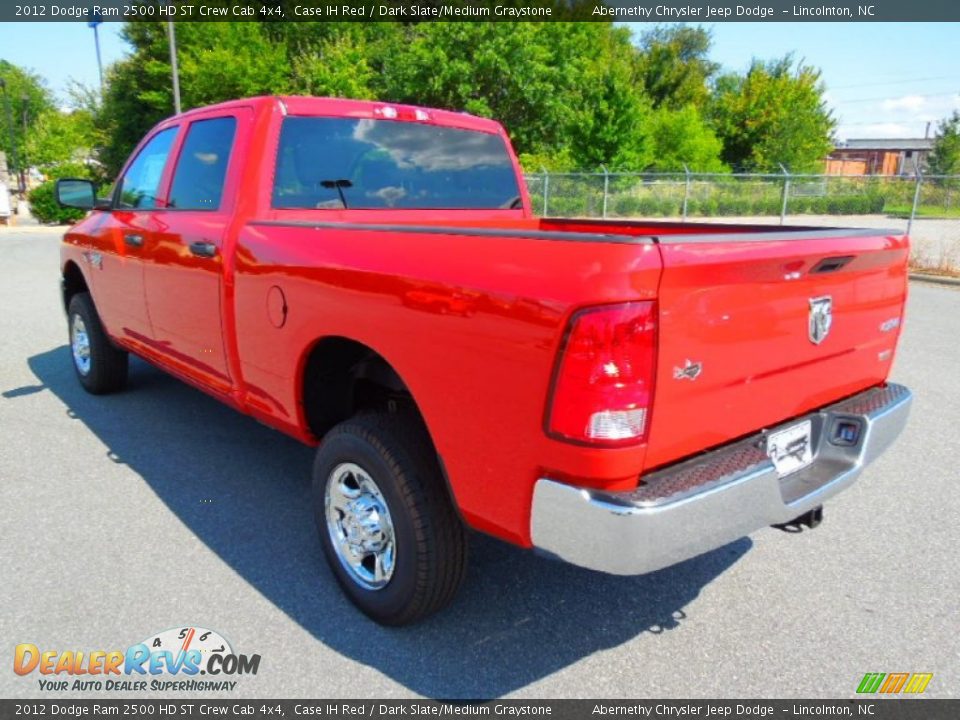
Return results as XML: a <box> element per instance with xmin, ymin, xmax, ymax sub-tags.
<box><xmin>526</xmin><ymin>172</ymin><xmax>960</xmax><ymax>272</ymax></box>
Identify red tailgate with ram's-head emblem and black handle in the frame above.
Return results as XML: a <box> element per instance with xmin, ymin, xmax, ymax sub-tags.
<box><xmin>647</xmin><ymin>229</ymin><xmax>908</xmax><ymax>467</ymax></box>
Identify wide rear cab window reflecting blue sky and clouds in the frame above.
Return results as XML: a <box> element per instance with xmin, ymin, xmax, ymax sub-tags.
<box><xmin>273</xmin><ymin>117</ymin><xmax>520</xmax><ymax>209</ymax></box>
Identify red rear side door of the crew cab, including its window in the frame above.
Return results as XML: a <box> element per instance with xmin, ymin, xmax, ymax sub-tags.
<box><xmin>145</xmin><ymin>108</ymin><xmax>249</xmax><ymax>392</ymax></box>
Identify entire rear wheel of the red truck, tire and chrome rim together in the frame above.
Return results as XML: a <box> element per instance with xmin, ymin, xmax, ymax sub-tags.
<box><xmin>313</xmin><ymin>413</ymin><xmax>467</xmax><ymax>625</ymax></box>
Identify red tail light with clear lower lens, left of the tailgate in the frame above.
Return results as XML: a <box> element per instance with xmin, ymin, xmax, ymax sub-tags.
<box><xmin>547</xmin><ymin>301</ymin><xmax>657</xmax><ymax>447</ymax></box>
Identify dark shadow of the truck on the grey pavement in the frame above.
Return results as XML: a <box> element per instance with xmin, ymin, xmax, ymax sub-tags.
<box><xmin>13</xmin><ymin>346</ymin><xmax>751</xmax><ymax>698</ymax></box>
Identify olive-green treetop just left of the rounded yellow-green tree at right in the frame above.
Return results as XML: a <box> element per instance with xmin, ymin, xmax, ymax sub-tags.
<box><xmin>636</xmin><ymin>25</ymin><xmax>719</xmax><ymax>110</ymax></box>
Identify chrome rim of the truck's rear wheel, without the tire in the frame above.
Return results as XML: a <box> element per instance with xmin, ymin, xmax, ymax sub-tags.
<box><xmin>324</xmin><ymin>463</ymin><xmax>396</xmax><ymax>590</ymax></box>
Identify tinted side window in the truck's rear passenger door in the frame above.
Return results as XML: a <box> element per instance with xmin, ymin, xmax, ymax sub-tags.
<box><xmin>169</xmin><ymin>117</ymin><xmax>237</xmax><ymax>210</ymax></box>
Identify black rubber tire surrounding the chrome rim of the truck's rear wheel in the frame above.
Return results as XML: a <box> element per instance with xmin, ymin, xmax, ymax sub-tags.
<box><xmin>313</xmin><ymin>412</ymin><xmax>467</xmax><ymax>626</ymax></box>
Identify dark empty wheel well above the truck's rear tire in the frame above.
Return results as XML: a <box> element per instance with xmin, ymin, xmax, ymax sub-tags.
<box><xmin>302</xmin><ymin>337</ymin><xmax>422</xmax><ymax>438</ymax></box>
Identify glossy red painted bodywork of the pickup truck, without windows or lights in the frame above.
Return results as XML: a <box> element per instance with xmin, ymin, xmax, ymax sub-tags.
<box><xmin>62</xmin><ymin>98</ymin><xmax>907</xmax><ymax>545</ymax></box>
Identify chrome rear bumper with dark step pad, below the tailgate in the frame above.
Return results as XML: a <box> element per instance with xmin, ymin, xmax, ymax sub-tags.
<box><xmin>531</xmin><ymin>384</ymin><xmax>912</xmax><ymax>575</ymax></box>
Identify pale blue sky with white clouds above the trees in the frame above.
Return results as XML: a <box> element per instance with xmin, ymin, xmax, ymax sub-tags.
<box><xmin>0</xmin><ymin>22</ymin><xmax>960</xmax><ymax>140</ymax></box>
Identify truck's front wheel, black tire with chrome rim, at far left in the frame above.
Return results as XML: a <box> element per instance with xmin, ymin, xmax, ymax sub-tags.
<box><xmin>67</xmin><ymin>292</ymin><xmax>129</xmax><ymax>395</ymax></box>
